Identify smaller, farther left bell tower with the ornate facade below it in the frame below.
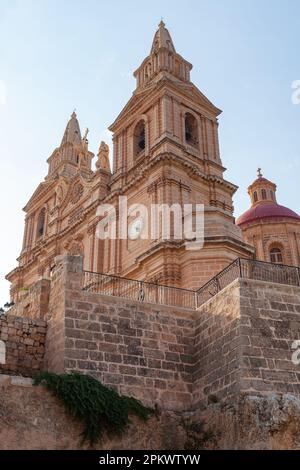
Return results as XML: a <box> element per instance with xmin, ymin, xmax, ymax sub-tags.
<box><xmin>6</xmin><ymin>111</ymin><xmax>96</xmax><ymax>305</ymax></box>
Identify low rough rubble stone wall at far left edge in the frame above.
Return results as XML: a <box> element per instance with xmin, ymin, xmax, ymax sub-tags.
<box><xmin>0</xmin><ymin>315</ymin><xmax>46</xmax><ymax>377</ymax></box>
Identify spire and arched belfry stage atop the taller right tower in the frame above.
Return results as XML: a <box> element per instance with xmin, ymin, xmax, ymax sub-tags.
<box><xmin>110</xmin><ymin>22</ymin><xmax>222</xmax><ymax>179</ymax></box>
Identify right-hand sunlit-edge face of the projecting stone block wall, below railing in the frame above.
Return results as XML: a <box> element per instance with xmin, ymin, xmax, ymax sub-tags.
<box><xmin>239</xmin><ymin>280</ymin><xmax>300</xmax><ymax>396</ymax></box>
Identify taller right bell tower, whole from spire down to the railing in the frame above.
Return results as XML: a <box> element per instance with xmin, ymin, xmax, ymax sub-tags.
<box><xmin>105</xmin><ymin>22</ymin><xmax>253</xmax><ymax>288</ymax></box>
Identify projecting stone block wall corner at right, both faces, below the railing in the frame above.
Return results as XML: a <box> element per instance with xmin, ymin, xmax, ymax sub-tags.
<box><xmin>193</xmin><ymin>279</ymin><xmax>300</xmax><ymax>406</ymax></box>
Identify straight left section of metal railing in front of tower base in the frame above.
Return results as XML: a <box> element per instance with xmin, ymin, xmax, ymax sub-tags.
<box><xmin>83</xmin><ymin>271</ymin><xmax>197</xmax><ymax>309</ymax></box>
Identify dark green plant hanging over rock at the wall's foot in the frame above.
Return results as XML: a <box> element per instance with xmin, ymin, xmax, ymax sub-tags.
<box><xmin>34</xmin><ymin>372</ymin><xmax>154</xmax><ymax>444</ymax></box>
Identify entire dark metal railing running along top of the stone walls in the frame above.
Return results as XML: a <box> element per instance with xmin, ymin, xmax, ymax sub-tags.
<box><xmin>82</xmin><ymin>258</ymin><xmax>300</xmax><ymax>309</ymax></box>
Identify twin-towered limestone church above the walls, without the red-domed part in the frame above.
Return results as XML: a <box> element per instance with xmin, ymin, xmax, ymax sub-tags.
<box><xmin>7</xmin><ymin>22</ymin><xmax>253</xmax><ymax>302</ymax></box>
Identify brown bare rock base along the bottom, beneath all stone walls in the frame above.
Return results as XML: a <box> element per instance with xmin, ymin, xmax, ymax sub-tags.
<box><xmin>0</xmin><ymin>375</ymin><xmax>300</xmax><ymax>450</ymax></box>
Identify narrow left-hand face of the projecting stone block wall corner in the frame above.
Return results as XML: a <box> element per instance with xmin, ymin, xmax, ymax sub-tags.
<box><xmin>193</xmin><ymin>280</ymin><xmax>241</xmax><ymax>407</ymax></box>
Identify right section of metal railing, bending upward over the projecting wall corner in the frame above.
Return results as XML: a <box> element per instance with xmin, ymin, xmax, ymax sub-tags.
<box><xmin>197</xmin><ymin>258</ymin><xmax>300</xmax><ymax>306</ymax></box>
